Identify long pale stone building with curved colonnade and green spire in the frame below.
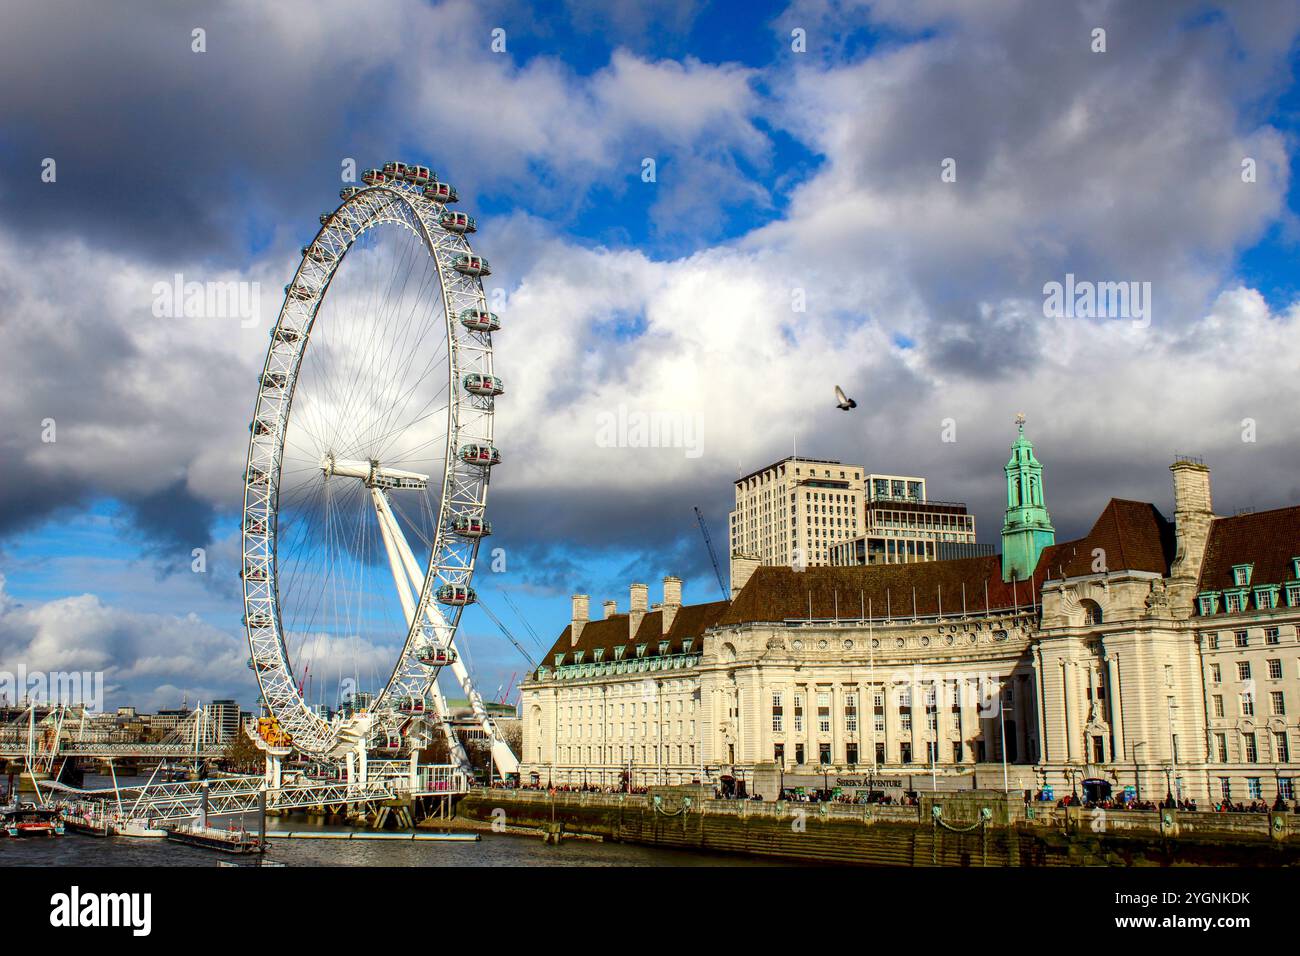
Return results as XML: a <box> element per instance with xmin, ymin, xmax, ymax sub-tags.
<box><xmin>520</xmin><ymin>423</ymin><xmax>1300</xmax><ymax>803</ymax></box>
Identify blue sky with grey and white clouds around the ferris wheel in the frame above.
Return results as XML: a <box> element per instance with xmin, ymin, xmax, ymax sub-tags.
<box><xmin>0</xmin><ymin>0</ymin><xmax>1300</xmax><ymax>708</ymax></box>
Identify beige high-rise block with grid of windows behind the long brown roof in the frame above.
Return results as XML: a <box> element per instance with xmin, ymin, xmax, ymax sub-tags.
<box><xmin>731</xmin><ymin>457</ymin><xmax>865</xmax><ymax>567</ymax></box>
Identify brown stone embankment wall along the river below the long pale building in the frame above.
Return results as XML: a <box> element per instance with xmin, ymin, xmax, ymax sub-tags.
<box><xmin>456</xmin><ymin>788</ymin><xmax>1300</xmax><ymax>866</ymax></box>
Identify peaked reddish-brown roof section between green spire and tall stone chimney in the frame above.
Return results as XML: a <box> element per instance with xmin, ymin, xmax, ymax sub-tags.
<box><xmin>1039</xmin><ymin>498</ymin><xmax>1174</xmax><ymax>579</ymax></box>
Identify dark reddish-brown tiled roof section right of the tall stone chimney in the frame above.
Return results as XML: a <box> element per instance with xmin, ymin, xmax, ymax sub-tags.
<box><xmin>1200</xmin><ymin>506</ymin><xmax>1300</xmax><ymax>591</ymax></box>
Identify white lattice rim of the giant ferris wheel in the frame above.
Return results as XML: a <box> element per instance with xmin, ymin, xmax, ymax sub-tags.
<box><xmin>241</xmin><ymin>170</ymin><xmax>499</xmax><ymax>756</ymax></box>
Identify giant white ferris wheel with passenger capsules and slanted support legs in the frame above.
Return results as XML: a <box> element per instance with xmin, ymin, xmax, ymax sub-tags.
<box><xmin>241</xmin><ymin>163</ymin><xmax>519</xmax><ymax>774</ymax></box>
